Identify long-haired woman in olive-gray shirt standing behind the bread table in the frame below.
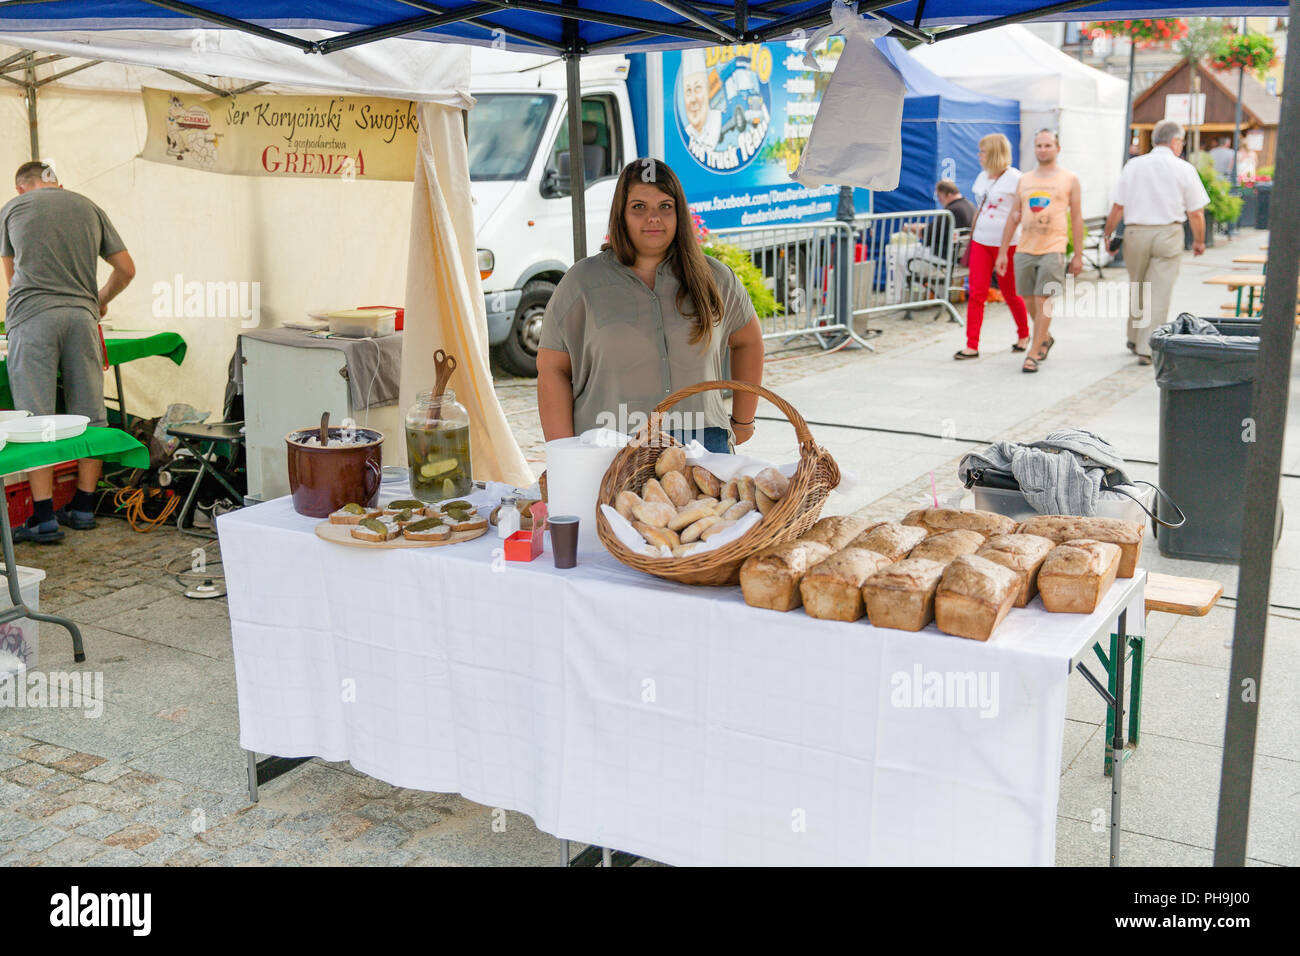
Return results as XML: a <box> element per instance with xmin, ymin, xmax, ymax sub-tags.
<box><xmin>537</xmin><ymin>159</ymin><xmax>763</xmax><ymax>453</ymax></box>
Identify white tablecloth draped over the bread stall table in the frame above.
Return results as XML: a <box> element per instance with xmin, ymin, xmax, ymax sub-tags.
<box><xmin>217</xmin><ymin>489</ymin><xmax>1145</xmax><ymax>865</ymax></box>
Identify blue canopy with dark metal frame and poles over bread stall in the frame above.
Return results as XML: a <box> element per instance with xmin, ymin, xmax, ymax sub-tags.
<box><xmin>0</xmin><ymin>0</ymin><xmax>1300</xmax><ymax>866</ymax></box>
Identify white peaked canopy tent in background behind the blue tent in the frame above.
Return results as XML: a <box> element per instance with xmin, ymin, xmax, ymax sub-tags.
<box><xmin>911</xmin><ymin>25</ymin><xmax>1128</xmax><ymax>219</ymax></box>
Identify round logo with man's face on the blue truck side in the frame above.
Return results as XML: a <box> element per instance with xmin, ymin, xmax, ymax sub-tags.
<box><xmin>673</xmin><ymin>43</ymin><xmax>772</xmax><ymax>173</ymax></box>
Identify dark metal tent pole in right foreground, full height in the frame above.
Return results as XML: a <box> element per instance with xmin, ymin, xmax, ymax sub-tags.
<box><xmin>1214</xmin><ymin>0</ymin><xmax>1300</xmax><ymax>866</ymax></box>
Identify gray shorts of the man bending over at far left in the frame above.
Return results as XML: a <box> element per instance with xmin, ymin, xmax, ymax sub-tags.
<box><xmin>8</xmin><ymin>306</ymin><xmax>108</xmax><ymax>425</ymax></box>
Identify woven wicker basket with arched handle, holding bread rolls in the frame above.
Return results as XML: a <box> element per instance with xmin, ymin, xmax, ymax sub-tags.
<box><xmin>595</xmin><ymin>381</ymin><xmax>840</xmax><ymax>585</ymax></box>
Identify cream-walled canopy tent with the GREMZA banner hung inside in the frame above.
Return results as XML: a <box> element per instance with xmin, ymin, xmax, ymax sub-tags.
<box><xmin>0</xmin><ymin>29</ymin><xmax>532</xmax><ymax>483</ymax></box>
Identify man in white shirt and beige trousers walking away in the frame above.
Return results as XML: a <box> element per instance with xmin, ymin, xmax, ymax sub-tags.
<box><xmin>1104</xmin><ymin>120</ymin><xmax>1210</xmax><ymax>365</ymax></box>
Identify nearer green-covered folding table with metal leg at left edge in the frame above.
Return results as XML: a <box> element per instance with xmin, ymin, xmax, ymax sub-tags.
<box><xmin>0</xmin><ymin>428</ymin><xmax>150</xmax><ymax>663</ymax></box>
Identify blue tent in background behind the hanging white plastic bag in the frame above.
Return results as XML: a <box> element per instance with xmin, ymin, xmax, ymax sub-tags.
<box><xmin>871</xmin><ymin>36</ymin><xmax>1021</xmax><ymax>212</ymax></box>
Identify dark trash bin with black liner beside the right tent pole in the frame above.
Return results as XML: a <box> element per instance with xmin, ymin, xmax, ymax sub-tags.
<box><xmin>1151</xmin><ymin>312</ymin><xmax>1282</xmax><ymax>562</ymax></box>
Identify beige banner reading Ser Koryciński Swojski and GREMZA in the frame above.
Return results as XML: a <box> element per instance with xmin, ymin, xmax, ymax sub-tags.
<box><xmin>140</xmin><ymin>88</ymin><xmax>420</xmax><ymax>182</ymax></box>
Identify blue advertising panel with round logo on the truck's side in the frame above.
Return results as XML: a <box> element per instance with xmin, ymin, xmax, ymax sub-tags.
<box><xmin>663</xmin><ymin>36</ymin><xmax>871</xmax><ymax>229</ymax></box>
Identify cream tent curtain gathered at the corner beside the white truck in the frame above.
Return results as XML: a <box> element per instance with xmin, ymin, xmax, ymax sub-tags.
<box><xmin>399</xmin><ymin>103</ymin><xmax>533</xmax><ymax>486</ymax></box>
